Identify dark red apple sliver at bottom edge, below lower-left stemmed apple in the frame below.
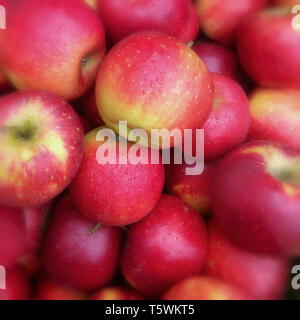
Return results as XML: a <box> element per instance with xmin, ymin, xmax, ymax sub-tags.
<box><xmin>35</xmin><ymin>278</ymin><xmax>86</xmax><ymax>300</ymax></box>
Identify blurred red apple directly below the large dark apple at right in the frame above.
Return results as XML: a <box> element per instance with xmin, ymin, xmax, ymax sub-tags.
<box><xmin>204</xmin><ymin>220</ymin><xmax>289</xmax><ymax>300</ymax></box>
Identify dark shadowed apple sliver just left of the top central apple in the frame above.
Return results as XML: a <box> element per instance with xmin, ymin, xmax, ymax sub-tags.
<box><xmin>80</xmin><ymin>88</ymin><xmax>104</xmax><ymax>127</ymax></box>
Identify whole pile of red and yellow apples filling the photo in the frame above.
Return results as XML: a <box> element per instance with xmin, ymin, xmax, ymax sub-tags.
<box><xmin>0</xmin><ymin>0</ymin><xmax>300</xmax><ymax>300</ymax></box>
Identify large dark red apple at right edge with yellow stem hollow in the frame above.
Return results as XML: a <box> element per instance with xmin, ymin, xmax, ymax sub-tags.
<box><xmin>213</xmin><ymin>141</ymin><xmax>300</xmax><ymax>256</ymax></box>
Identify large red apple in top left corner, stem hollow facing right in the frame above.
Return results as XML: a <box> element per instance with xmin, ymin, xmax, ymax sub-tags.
<box><xmin>0</xmin><ymin>0</ymin><xmax>105</xmax><ymax>100</ymax></box>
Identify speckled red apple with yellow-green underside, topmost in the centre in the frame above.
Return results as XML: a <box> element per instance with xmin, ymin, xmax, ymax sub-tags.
<box><xmin>96</xmin><ymin>32</ymin><xmax>214</xmax><ymax>148</ymax></box>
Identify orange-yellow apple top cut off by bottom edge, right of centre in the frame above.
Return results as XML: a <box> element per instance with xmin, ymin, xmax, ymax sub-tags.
<box><xmin>162</xmin><ymin>276</ymin><xmax>249</xmax><ymax>300</ymax></box>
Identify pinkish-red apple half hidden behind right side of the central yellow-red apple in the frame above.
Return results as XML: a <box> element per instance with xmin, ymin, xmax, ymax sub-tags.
<box><xmin>186</xmin><ymin>74</ymin><xmax>251</xmax><ymax>161</ymax></box>
